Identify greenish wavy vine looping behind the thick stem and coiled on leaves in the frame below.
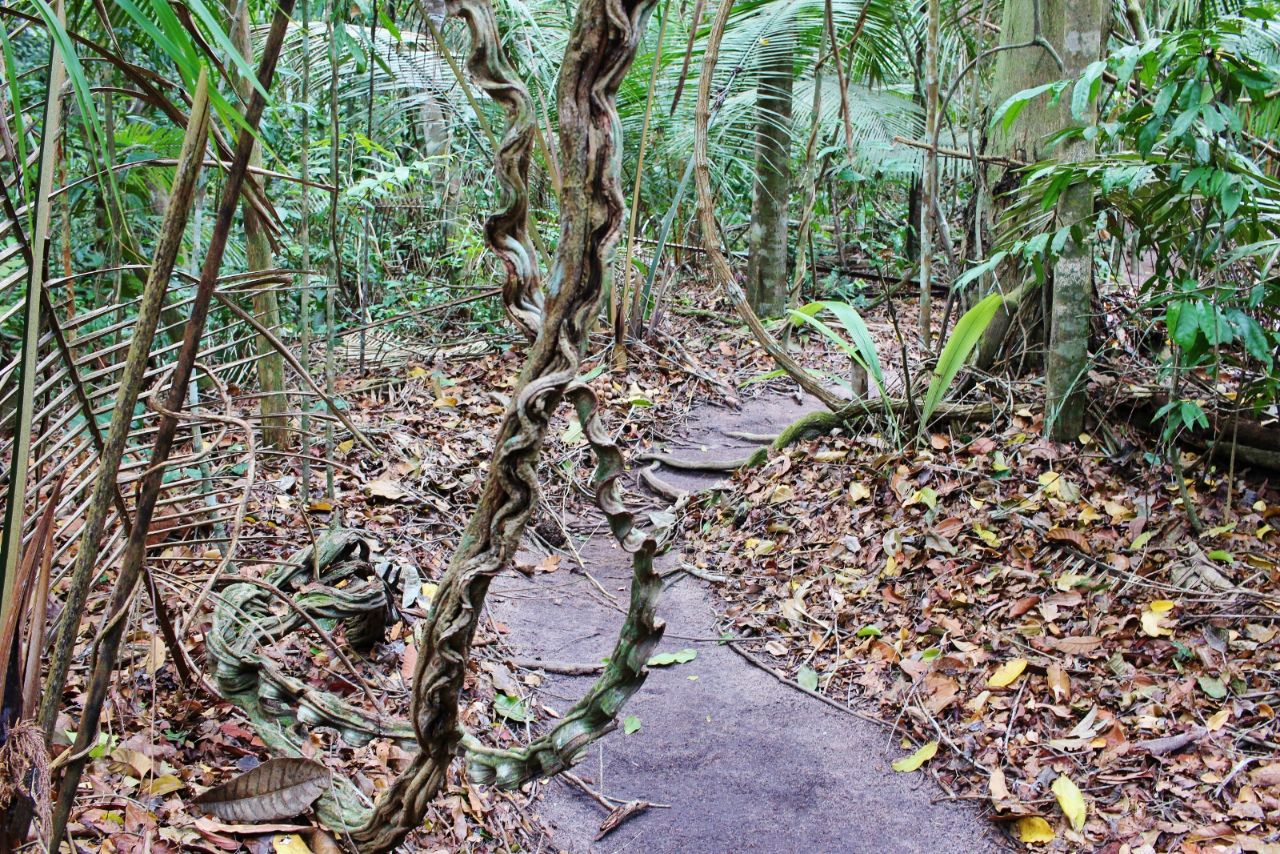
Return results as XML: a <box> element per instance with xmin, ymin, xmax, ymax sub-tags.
<box><xmin>207</xmin><ymin>383</ymin><xmax>666</xmax><ymax>831</ymax></box>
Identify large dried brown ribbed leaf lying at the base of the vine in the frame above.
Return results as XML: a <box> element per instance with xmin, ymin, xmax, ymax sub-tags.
<box><xmin>195</xmin><ymin>759</ymin><xmax>330</xmax><ymax>822</ymax></box>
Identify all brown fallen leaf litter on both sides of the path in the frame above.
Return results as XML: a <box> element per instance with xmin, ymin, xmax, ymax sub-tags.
<box><xmin>59</xmin><ymin>279</ymin><xmax>1280</xmax><ymax>851</ymax></box>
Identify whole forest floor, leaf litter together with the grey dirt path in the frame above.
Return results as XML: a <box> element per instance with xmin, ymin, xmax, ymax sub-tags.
<box><xmin>55</xmin><ymin>289</ymin><xmax>1280</xmax><ymax>853</ymax></box>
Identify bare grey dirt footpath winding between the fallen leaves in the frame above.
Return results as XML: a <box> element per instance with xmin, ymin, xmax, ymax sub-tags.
<box><xmin>489</xmin><ymin>396</ymin><xmax>1005</xmax><ymax>854</ymax></box>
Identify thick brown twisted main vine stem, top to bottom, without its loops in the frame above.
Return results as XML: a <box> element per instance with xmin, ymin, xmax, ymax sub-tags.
<box><xmin>352</xmin><ymin>0</ymin><xmax>654</xmax><ymax>851</ymax></box>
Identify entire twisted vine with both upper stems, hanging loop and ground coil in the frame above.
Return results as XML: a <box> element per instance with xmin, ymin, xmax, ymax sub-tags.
<box><xmin>198</xmin><ymin>0</ymin><xmax>663</xmax><ymax>851</ymax></box>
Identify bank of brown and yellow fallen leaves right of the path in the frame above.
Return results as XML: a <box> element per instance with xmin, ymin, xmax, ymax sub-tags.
<box><xmin>685</xmin><ymin>398</ymin><xmax>1280</xmax><ymax>851</ymax></box>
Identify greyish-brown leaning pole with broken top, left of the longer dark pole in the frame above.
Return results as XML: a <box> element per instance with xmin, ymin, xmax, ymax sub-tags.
<box><xmin>38</xmin><ymin>73</ymin><xmax>209</xmax><ymax>740</ymax></box>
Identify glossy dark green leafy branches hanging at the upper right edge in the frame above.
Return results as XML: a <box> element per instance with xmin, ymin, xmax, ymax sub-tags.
<box><xmin>983</xmin><ymin>3</ymin><xmax>1280</xmax><ymax>434</ymax></box>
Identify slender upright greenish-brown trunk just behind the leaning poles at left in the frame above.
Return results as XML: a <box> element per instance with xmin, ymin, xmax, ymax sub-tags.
<box><xmin>236</xmin><ymin>3</ymin><xmax>289</xmax><ymax>448</ymax></box>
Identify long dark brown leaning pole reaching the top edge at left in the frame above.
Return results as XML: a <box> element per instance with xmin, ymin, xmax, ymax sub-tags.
<box><xmin>46</xmin><ymin>10</ymin><xmax>293</xmax><ymax>844</ymax></box>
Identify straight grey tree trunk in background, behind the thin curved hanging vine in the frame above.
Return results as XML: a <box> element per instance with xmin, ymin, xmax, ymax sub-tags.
<box><xmin>746</xmin><ymin>32</ymin><xmax>795</xmax><ymax>318</ymax></box>
